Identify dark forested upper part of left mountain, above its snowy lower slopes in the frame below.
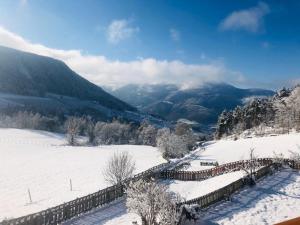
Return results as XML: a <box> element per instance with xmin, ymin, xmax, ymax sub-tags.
<box><xmin>0</xmin><ymin>47</ymin><xmax>135</xmax><ymax>111</ymax></box>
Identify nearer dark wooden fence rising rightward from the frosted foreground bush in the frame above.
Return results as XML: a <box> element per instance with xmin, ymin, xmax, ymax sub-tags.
<box><xmin>179</xmin><ymin>160</ymin><xmax>300</xmax><ymax>209</ymax></box>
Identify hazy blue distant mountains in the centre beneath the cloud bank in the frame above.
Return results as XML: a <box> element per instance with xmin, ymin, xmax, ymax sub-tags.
<box><xmin>107</xmin><ymin>83</ymin><xmax>274</xmax><ymax>129</ymax></box>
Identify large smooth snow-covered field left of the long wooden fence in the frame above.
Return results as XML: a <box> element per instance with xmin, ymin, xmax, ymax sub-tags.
<box><xmin>0</xmin><ymin>129</ymin><xmax>165</xmax><ymax>221</ymax></box>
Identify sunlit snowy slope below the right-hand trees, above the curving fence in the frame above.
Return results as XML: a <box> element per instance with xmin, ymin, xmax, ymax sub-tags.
<box><xmin>187</xmin><ymin>133</ymin><xmax>300</xmax><ymax>170</ymax></box>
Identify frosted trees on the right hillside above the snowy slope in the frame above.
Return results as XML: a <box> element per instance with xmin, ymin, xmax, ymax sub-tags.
<box><xmin>215</xmin><ymin>86</ymin><xmax>300</xmax><ymax>139</ymax></box>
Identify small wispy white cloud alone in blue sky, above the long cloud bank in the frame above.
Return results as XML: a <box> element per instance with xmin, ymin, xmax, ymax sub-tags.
<box><xmin>106</xmin><ymin>20</ymin><xmax>139</xmax><ymax>44</ymax></box>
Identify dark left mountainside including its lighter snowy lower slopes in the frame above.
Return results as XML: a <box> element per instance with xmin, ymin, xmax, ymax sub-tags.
<box><xmin>0</xmin><ymin>46</ymin><xmax>164</xmax><ymax>121</ymax></box>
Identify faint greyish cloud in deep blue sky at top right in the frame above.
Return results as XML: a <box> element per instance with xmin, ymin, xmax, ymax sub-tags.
<box><xmin>219</xmin><ymin>2</ymin><xmax>270</xmax><ymax>33</ymax></box>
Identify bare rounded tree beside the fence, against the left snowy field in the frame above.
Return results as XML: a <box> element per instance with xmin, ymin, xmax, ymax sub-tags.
<box><xmin>103</xmin><ymin>152</ymin><xmax>135</xmax><ymax>185</ymax></box>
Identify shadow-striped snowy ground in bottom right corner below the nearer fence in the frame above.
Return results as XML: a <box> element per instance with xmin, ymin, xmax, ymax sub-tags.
<box><xmin>200</xmin><ymin>170</ymin><xmax>300</xmax><ymax>225</ymax></box>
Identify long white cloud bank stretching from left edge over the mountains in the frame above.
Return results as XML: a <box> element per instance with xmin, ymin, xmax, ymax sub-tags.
<box><xmin>0</xmin><ymin>27</ymin><xmax>243</xmax><ymax>87</ymax></box>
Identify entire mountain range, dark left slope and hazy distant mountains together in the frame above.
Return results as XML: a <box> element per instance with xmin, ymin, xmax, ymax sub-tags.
<box><xmin>0</xmin><ymin>46</ymin><xmax>274</xmax><ymax>130</ymax></box>
